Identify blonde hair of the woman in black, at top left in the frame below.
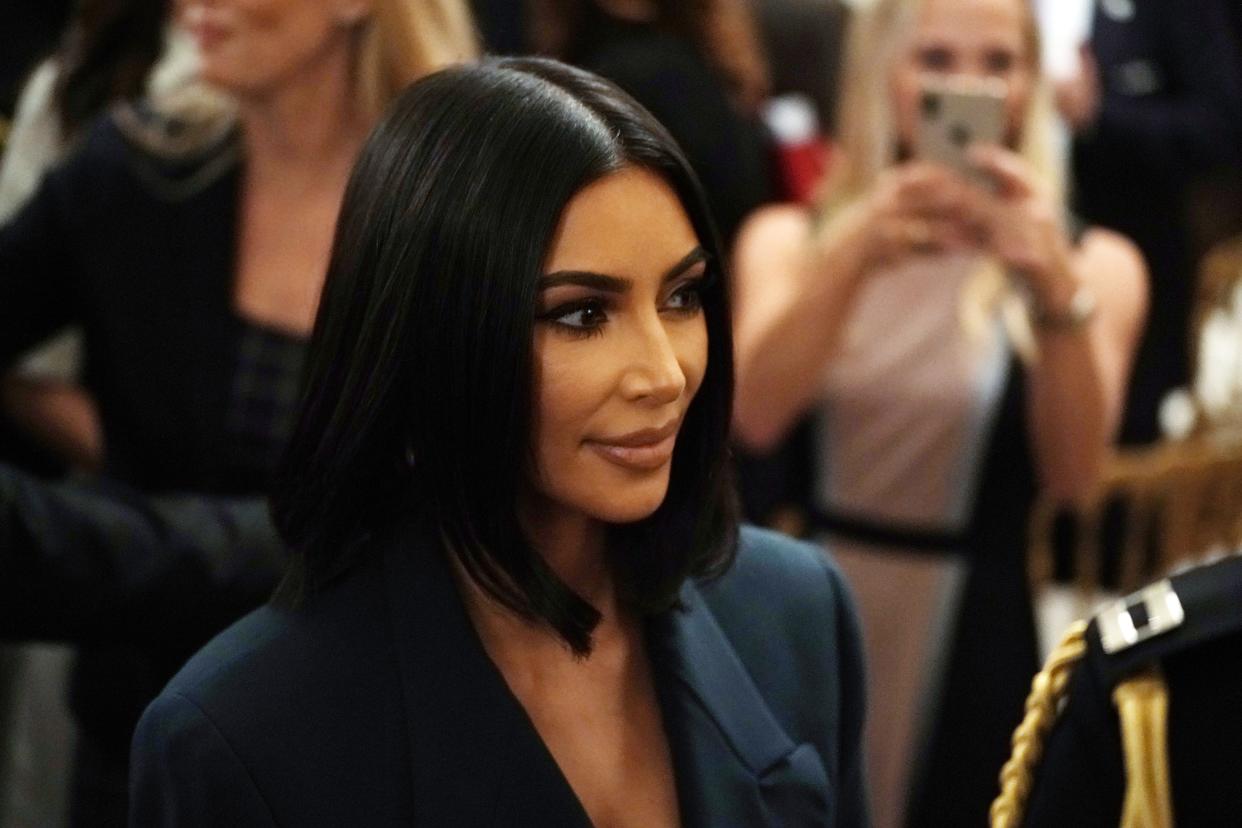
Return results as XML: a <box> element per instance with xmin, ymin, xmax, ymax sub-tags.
<box><xmin>355</xmin><ymin>0</ymin><xmax>479</xmax><ymax>118</ymax></box>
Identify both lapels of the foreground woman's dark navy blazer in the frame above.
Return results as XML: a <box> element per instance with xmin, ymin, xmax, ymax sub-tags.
<box><xmin>378</xmin><ymin>523</ymin><xmax>828</xmax><ymax>827</ymax></box>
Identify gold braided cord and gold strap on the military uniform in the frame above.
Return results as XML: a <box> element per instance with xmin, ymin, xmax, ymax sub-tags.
<box><xmin>990</xmin><ymin>621</ymin><xmax>1174</xmax><ymax>828</ymax></box>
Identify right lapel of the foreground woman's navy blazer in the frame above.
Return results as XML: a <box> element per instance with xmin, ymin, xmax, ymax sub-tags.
<box><xmin>647</xmin><ymin>581</ymin><xmax>833</xmax><ymax>827</ymax></box>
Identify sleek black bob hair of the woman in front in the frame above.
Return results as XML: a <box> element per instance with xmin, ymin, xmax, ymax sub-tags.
<box><xmin>272</xmin><ymin>58</ymin><xmax>738</xmax><ymax>654</ymax></box>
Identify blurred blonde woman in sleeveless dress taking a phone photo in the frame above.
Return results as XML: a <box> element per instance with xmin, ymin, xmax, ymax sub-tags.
<box><xmin>735</xmin><ymin>0</ymin><xmax>1146</xmax><ymax>826</ymax></box>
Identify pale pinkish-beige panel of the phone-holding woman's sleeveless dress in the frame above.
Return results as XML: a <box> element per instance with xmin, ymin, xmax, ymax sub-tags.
<box><xmin>814</xmin><ymin>254</ymin><xmax>1011</xmax><ymax>828</ymax></box>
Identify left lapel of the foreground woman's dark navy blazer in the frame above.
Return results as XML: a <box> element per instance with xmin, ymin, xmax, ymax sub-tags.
<box><xmin>378</xmin><ymin>524</ymin><xmax>590</xmax><ymax>827</ymax></box>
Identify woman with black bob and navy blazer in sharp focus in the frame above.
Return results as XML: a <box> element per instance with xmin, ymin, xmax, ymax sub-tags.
<box><xmin>132</xmin><ymin>60</ymin><xmax>866</xmax><ymax>827</ymax></box>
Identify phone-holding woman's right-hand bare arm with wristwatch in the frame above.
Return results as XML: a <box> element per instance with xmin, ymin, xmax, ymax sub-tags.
<box><xmin>975</xmin><ymin>148</ymin><xmax>1146</xmax><ymax>499</ymax></box>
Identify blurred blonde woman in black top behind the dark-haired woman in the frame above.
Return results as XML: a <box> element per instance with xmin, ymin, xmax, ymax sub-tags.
<box><xmin>0</xmin><ymin>0</ymin><xmax>474</xmax><ymax>824</ymax></box>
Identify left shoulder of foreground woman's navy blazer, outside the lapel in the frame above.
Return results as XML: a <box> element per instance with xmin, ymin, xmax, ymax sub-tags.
<box><xmin>130</xmin><ymin>561</ymin><xmax>409</xmax><ymax>826</ymax></box>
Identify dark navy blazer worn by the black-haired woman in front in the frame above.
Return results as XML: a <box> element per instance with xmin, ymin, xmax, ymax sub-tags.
<box><xmin>130</xmin><ymin>528</ymin><xmax>867</xmax><ymax>828</ymax></box>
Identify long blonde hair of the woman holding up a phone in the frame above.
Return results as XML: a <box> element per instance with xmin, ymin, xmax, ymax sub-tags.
<box><xmin>818</xmin><ymin>0</ymin><xmax>1064</xmax><ymax>362</ymax></box>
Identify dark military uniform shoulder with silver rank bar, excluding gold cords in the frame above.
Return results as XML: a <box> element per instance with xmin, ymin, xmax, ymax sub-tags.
<box><xmin>1021</xmin><ymin>555</ymin><xmax>1242</xmax><ymax>828</ymax></box>
